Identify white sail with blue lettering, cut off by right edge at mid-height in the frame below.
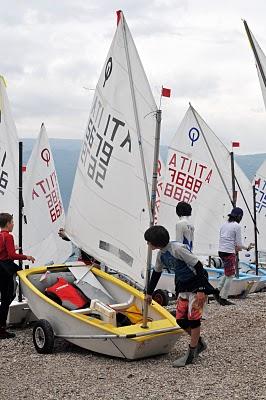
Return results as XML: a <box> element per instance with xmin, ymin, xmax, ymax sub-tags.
<box><xmin>254</xmin><ymin>160</ymin><xmax>266</xmax><ymax>252</ymax></box>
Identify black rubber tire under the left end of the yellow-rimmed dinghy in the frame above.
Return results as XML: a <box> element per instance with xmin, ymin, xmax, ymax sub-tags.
<box><xmin>32</xmin><ymin>319</ymin><xmax>54</xmax><ymax>354</ymax></box>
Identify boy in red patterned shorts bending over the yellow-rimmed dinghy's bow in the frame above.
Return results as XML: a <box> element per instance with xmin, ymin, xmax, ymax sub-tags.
<box><xmin>144</xmin><ymin>225</ymin><xmax>216</xmax><ymax>367</ymax></box>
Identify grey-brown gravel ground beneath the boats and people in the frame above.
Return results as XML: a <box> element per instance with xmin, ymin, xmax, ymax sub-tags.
<box><xmin>0</xmin><ymin>293</ymin><xmax>266</xmax><ymax>400</ymax></box>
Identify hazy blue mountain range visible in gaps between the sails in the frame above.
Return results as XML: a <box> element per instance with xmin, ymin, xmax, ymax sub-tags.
<box><xmin>22</xmin><ymin>139</ymin><xmax>266</xmax><ymax>210</ymax></box>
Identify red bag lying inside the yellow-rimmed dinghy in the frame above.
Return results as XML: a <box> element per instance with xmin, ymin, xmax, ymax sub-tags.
<box><xmin>45</xmin><ymin>277</ymin><xmax>88</xmax><ymax>310</ymax></box>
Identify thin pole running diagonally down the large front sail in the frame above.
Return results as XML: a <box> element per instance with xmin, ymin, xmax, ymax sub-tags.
<box><xmin>122</xmin><ymin>15</ymin><xmax>152</xmax><ymax>221</ymax></box>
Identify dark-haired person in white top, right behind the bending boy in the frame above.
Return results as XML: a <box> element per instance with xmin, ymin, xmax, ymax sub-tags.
<box><xmin>176</xmin><ymin>201</ymin><xmax>194</xmax><ymax>251</ymax></box>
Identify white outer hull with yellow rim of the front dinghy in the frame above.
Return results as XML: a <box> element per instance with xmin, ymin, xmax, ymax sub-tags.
<box><xmin>20</xmin><ymin>268</ymin><xmax>182</xmax><ymax>360</ymax></box>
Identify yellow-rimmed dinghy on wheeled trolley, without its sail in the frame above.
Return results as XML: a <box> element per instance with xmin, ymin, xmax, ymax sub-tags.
<box><xmin>18</xmin><ymin>265</ymin><xmax>182</xmax><ymax>360</ymax></box>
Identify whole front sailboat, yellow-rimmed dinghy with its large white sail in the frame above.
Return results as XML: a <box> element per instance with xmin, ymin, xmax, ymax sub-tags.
<box><xmin>19</xmin><ymin>11</ymin><xmax>182</xmax><ymax>359</ymax></box>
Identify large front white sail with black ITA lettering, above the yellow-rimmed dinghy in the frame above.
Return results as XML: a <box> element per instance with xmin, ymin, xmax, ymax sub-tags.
<box><xmin>66</xmin><ymin>13</ymin><xmax>157</xmax><ymax>284</ymax></box>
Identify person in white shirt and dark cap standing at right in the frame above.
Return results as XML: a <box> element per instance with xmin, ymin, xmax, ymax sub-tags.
<box><xmin>217</xmin><ymin>207</ymin><xmax>253</xmax><ymax>306</ymax></box>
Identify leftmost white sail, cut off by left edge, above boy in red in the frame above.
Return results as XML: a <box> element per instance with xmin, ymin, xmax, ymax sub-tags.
<box><xmin>0</xmin><ymin>76</ymin><xmax>19</xmax><ymax>240</ymax></box>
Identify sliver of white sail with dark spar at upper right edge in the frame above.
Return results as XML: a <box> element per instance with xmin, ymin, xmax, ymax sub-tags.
<box><xmin>244</xmin><ymin>21</ymin><xmax>266</xmax><ymax>108</ymax></box>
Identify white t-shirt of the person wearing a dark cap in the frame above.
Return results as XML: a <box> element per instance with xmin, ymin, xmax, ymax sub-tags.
<box><xmin>219</xmin><ymin>221</ymin><xmax>242</xmax><ymax>253</ymax></box>
